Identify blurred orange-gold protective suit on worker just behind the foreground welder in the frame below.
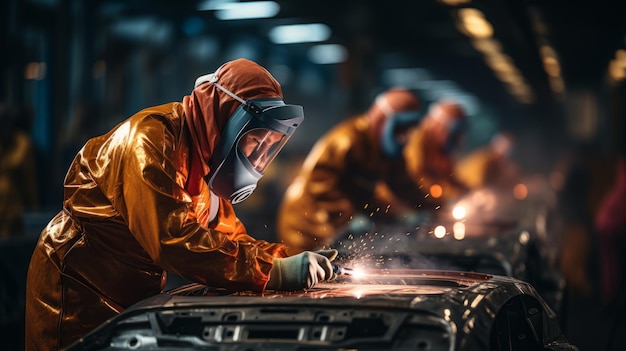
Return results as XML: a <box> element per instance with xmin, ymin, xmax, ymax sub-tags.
<box><xmin>277</xmin><ymin>115</ymin><xmax>425</xmax><ymax>254</ymax></box>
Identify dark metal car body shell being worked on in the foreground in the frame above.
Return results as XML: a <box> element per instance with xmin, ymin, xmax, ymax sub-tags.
<box><xmin>68</xmin><ymin>269</ymin><xmax>576</xmax><ymax>351</ymax></box>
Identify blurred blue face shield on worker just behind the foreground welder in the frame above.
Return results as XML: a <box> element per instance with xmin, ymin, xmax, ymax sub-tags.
<box><xmin>381</xmin><ymin>111</ymin><xmax>420</xmax><ymax>157</ymax></box>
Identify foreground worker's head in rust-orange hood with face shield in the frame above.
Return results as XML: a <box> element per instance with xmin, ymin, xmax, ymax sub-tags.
<box><xmin>180</xmin><ymin>59</ymin><xmax>304</xmax><ymax>203</ymax></box>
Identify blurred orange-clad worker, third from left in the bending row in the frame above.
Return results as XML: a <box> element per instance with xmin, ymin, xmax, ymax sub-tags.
<box><xmin>404</xmin><ymin>99</ymin><xmax>468</xmax><ymax>206</ymax></box>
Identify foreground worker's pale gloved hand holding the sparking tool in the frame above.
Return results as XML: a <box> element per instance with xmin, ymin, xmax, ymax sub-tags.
<box><xmin>267</xmin><ymin>249</ymin><xmax>338</xmax><ymax>291</ymax></box>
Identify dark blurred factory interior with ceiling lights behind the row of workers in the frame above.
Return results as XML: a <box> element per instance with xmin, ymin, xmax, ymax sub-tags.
<box><xmin>0</xmin><ymin>0</ymin><xmax>626</xmax><ymax>351</ymax></box>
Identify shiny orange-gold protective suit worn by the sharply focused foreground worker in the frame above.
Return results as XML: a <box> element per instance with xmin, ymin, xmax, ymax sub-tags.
<box><xmin>26</xmin><ymin>59</ymin><xmax>286</xmax><ymax>350</ymax></box>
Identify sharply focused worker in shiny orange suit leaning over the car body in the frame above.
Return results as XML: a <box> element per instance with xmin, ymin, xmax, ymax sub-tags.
<box><xmin>26</xmin><ymin>59</ymin><xmax>336</xmax><ymax>350</ymax></box>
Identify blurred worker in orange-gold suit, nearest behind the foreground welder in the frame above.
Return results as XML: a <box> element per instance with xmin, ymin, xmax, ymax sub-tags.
<box><xmin>277</xmin><ymin>88</ymin><xmax>420</xmax><ymax>254</ymax></box>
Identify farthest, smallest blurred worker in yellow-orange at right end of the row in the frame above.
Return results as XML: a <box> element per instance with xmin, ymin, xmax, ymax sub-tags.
<box><xmin>454</xmin><ymin>132</ymin><xmax>520</xmax><ymax>189</ymax></box>
